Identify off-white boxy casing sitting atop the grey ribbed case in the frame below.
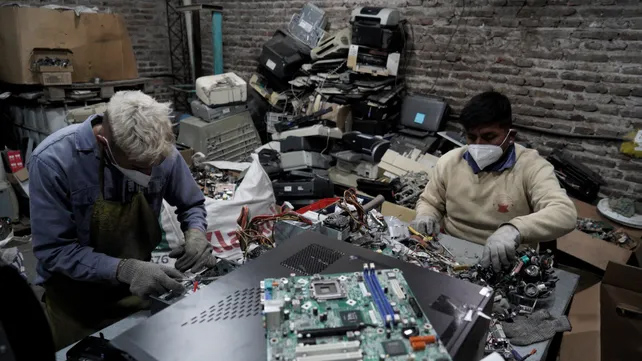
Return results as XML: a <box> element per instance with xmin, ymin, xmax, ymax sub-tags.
<box><xmin>196</xmin><ymin>73</ymin><xmax>247</xmax><ymax>106</ymax></box>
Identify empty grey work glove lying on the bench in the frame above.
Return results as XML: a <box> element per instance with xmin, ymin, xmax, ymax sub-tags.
<box><xmin>502</xmin><ymin>310</ymin><xmax>571</xmax><ymax>346</ymax></box>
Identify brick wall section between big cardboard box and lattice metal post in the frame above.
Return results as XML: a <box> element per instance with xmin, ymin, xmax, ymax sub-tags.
<box><xmin>20</xmin><ymin>0</ymin><xmax>171</xmax><ymax>100</ymax></box>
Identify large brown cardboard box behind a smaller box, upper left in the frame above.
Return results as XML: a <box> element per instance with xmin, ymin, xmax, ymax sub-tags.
<box><xmin>0</xmin><ymin>7</ymin><xmax>138</xmax><ymax>84</ymax></box>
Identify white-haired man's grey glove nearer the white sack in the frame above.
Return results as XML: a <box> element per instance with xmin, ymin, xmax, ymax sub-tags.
<box><xmin>169</xmin><ymin>229</ymin><xmax>216</xmax><ymax>273</ymax></box>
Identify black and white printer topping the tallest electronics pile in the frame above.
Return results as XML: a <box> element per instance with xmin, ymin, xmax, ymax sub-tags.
<box><xmin>350</xmin><ymin>6</ymin><xmax>403</xmax><ymax>51</ymax></box>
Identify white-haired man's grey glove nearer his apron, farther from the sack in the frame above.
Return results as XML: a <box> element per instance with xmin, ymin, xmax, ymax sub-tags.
<box><xmin>116</xmin><ymin>259</ymin><xmax>183</xmax><ymax>297</ymax></box>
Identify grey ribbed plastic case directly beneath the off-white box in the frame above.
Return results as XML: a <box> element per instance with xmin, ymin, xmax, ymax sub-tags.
<box><xmin>178</xmin><ymin>111</ymin><xmax>261</xmax><ymax>161</ymax></box>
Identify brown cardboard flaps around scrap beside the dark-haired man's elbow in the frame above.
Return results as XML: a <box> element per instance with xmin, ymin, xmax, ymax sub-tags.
<box><xmin>557</xmin><ymin>199</ymin><xmax>642</xmax><ymax>270</ymax></box>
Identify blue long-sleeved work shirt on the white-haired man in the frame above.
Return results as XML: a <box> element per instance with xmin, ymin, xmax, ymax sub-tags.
<box><xmin>27</xmin><ymin>115</ymin><xmax>207</xmax><ymax>284</ymax></box>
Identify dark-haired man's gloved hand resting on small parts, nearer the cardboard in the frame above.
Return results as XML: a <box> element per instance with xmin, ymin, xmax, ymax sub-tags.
<box><xmin>481</xmin><ymin>225</ymin><xmax>520</xmax><ymax>272</ymax></box>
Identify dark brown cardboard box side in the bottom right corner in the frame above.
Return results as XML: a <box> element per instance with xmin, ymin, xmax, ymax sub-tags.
<box><xmin>600</xmin><ymin>262</ymin><xmax>642</xmax><ymax>361</ymax></box>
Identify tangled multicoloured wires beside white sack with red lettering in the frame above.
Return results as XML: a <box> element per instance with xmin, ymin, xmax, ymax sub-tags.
<box><xmin>236</xmin><ymin>206</ymin><xmax>312</xmax><ymax>258</ymax></box>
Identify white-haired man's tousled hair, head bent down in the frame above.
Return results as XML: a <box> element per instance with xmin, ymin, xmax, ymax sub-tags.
<box><xmin>107</xmin><ymin>91</ymin><xmax>174</xmax><ymax>164</ymax></box>
